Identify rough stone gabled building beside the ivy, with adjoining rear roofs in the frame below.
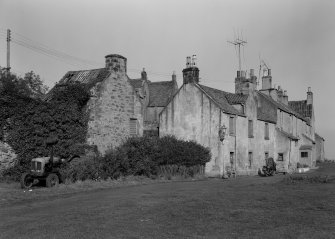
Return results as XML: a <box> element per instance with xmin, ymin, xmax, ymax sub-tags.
<box><xmin>45</xmin><ymin>54</ymin><xmax>178</xmax><ymax>154</ymax></box>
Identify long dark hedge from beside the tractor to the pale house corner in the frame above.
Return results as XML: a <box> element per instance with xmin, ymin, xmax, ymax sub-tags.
<box><xmin>64</xmin><ymin>136</ymin><xmax>211</xmax><ymax>182</ymax></box>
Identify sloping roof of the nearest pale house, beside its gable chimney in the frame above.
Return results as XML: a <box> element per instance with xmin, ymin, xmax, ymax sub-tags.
<box><xmin>196</xmin><ymin>84</ymin><xmax>244</xmax><ymax>116</ymax></box>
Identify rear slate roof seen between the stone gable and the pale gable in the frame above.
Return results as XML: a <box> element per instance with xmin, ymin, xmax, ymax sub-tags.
<box><xmin>148</xmin><ymin>81</ymin><xmax>175</xmax><ymax>107</ymax></box>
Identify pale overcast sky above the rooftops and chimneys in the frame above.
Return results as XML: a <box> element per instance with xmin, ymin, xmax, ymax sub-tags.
<box><xmin>0</xmin><ymin>0</ymin><xmax>335</xmax><ymax>158</ymax></box>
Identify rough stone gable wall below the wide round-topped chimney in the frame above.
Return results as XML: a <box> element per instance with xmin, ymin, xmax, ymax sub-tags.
<box><xmin>87</xmin><ymin>68</ymin><xmax>143</xmax><ymax>154</ymax></box>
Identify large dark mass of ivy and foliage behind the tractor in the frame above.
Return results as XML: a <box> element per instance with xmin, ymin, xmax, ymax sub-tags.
<box><xmin>0</xmin><ymin>69</ymin><xmax>89</xmax><ymax>170</ymax></box>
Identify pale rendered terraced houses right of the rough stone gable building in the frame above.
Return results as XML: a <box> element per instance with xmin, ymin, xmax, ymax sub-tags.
<box><xmin>159</xmin><ymin>56</ymin><xmax>324</xmax><ymax>176</ymax></box>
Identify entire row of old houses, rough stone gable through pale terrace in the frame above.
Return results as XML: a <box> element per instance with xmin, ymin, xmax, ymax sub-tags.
<box><xmin>41</xmin><ymin>54</ymin><xmax>324</xmax><ymax>176</ymax></box>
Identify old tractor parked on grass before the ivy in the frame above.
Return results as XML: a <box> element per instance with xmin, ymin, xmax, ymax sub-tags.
<box><xmin>21</xmin><ymin>139</ymin><xmax>79</xmax><ymax>189</ymax></box>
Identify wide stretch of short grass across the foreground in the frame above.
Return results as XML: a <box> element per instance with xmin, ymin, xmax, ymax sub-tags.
<box><xmin>0</xmin><ymin>164</ymin><xmax>335</xmax><ymax>238</ymax></box>
